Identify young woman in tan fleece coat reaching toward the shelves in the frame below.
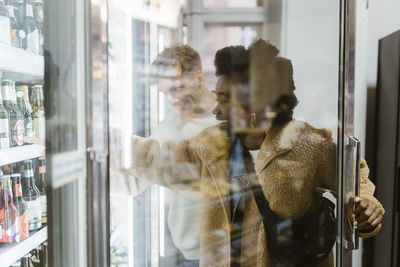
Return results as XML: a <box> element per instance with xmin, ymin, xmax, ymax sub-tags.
<box><xmin>126</xmin><ymin>40</ymin><xmax>384</xmax><ymax>266</ymax></box>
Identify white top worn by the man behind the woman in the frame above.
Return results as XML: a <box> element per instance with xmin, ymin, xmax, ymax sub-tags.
<box><xmin>150</xmin><ymin>105</ymin><xmax>218</xmax><ymax>260</ymax></box>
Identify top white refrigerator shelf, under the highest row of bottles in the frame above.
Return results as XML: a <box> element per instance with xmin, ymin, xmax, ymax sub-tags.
<box><xmin>0</xmin><ymin>44</ymin><xmax>44</xmax><ymax>82</ymax></box>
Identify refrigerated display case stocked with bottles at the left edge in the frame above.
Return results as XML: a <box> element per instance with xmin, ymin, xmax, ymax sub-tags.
<box><xmin>0</xmin><ymin>1</ymin><xmax>48</xmax><ymax>266</ymax></box>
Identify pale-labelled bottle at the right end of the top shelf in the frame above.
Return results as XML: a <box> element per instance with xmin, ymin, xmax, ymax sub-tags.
<box><xmin>23</xmin><ymin>0</ymin><xmax>39</xmax><ymax>54</ymax></box>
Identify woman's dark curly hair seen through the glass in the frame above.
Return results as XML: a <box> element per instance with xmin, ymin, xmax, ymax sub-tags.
<box><xmin>214</xmin><ymin>39</ymin><xmax>298</xmax><ymax>124</ymax></box>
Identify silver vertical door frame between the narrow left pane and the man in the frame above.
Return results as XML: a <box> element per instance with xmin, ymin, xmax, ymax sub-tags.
<box><xmin>85</xmin><ymin>0</ymin><xmax>110</xmax><ymax>267</ymax></box>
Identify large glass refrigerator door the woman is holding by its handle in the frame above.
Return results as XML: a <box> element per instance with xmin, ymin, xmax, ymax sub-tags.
<box><xmin>108</xmin><ymin>0</ymin><xmax>358</xmax><ymax>266</ymax></box>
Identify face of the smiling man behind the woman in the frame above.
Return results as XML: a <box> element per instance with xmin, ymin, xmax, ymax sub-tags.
<box><xmin>158</xmin><ymin>73</ymin><xmax>201</xmax><ymax>116</ymax></box>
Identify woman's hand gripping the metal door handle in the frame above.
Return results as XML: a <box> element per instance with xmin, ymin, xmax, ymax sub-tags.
<box><xmin>349</xmin><ymin>197</ymin><xmax>383</xmax><ymax>232</ymax></box>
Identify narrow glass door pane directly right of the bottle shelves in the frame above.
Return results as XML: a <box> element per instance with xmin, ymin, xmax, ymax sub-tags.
<box><xmin>44</xmin><ymin>1</ymin><xmax>88</xmax><ymax>266</ymax></box>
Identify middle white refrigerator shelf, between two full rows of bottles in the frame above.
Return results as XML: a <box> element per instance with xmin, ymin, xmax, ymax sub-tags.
<box><xmin>0</xmin><ymin>144</ymin><xmax>45</xmax><ymax>166</ymax></box>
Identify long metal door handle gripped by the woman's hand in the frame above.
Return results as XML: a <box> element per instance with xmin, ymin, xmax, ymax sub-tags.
<box><xmin>348</xmin><ymin>136</ymin><xmax>361</xmax><ymax>250</ymax></box>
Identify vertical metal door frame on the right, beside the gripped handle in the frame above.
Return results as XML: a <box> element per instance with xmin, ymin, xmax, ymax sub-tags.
<box><xmin>336</xmin><ymin>0</ymin><xmax>358</xmax><ymax>266</ymax></box>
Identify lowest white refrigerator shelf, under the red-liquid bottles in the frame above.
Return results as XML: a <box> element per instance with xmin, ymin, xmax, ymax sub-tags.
<box><xmin>0</xmin><ymin>226</ymin><xmax>47</xmax><ymax>267</ymax></box>
